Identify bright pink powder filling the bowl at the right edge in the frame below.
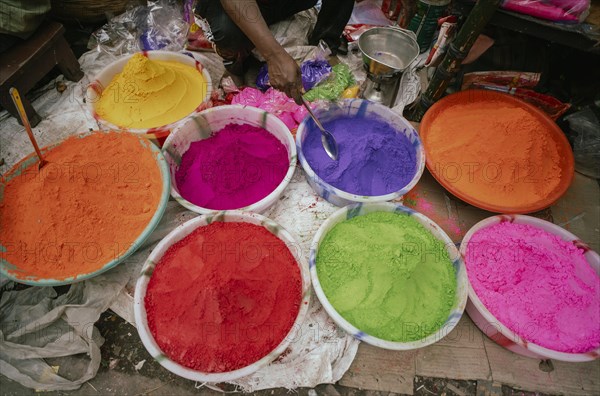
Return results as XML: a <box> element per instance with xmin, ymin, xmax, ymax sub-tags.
<box><xmin>465</xmin><ymin>222</ymin><xmax>600</xmax><ymax>353</ymax></box>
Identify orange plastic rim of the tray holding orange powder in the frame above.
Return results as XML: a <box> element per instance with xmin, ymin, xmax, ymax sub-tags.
<box><xmin>419</xmin><ymin>90</ymin><xmax>574</xmax><ymax>214</ymax></box>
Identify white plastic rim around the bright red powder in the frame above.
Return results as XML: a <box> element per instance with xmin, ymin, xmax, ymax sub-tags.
<box><xmin>133</xmin><ymin>210</ymin><xmax>311</xmax><ymax>383</ymax></box>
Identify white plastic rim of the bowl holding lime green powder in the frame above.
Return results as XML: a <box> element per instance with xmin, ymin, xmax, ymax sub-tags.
<box><xmin>309</xmin><ymin>202</ymin><xmax>468</xmax><ymax>350</ymax></box>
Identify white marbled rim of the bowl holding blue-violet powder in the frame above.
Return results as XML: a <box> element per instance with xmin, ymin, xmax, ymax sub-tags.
<box><xmin>296</xmin><ymin>99</ymin><xmax>425</xmax><ymax>207</ymax></box>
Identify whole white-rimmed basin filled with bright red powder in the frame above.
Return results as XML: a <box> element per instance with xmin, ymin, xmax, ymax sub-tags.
<box><xmin>134</xmin><ymin>211</ymin><xmax>311</xmax><ymax>383</ymax></box>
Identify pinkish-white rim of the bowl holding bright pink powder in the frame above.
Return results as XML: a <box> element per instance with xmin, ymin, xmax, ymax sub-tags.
<box><xmin>460</xmin><ymin>215</ymin><xmax>600</xmax><ymax>362</ymax></box>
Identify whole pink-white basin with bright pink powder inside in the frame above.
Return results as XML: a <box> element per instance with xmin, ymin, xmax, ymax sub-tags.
<box><xmin>460</xmin><ymin>215</ymin><xmax>600</xmax><ymax>362</ymax></box>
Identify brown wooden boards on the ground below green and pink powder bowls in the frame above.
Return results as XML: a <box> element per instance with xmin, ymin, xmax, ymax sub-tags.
<box><xmin>339</xmin><ymin>315</ymin><xmax>600</xmax><ymax>395</ymax></box>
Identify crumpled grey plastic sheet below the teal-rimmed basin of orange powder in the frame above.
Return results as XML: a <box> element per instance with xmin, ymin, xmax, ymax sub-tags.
<box><xmin>0</xmin><ymin>264</ymin><xmax>127</xmax><ymax>391</ymax></box>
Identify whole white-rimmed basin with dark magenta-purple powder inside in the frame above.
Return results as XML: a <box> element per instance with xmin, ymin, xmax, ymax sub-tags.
<box><xmin>163</xmin><ymin>105</ymin><xmax>296</xmax><ymax>214</ymax></box>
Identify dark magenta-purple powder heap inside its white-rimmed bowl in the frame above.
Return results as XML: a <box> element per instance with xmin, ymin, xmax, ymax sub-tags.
<box><xmin>175</xmin><ymin>124</ymin><xmax>290</xmax><ymax>210</ymax></box>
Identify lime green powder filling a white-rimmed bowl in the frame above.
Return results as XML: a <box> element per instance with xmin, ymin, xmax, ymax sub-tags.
<box><xmin>317</xmin><ymin>212</ymin><xmax>456</xmax><ymax>342</ymax></box>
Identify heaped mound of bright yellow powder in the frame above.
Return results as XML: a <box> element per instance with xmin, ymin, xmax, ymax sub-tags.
<box><xmin>95</xmin><ymin>53</ymin><xmax>207</xmax><ymax>128</ymax></box>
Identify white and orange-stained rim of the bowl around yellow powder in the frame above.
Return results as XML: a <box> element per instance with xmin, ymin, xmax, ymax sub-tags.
<box><xmin>85</xmin><ymin>50</ymin><xmax>212</xmax><ymax>137</ymax></box>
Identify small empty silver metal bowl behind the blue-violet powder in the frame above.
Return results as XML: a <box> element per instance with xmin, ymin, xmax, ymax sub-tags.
<box><xmin>358</xmin><ymin>27</ymin><xmax>419</xmax><ymax>76</ymax></box>
